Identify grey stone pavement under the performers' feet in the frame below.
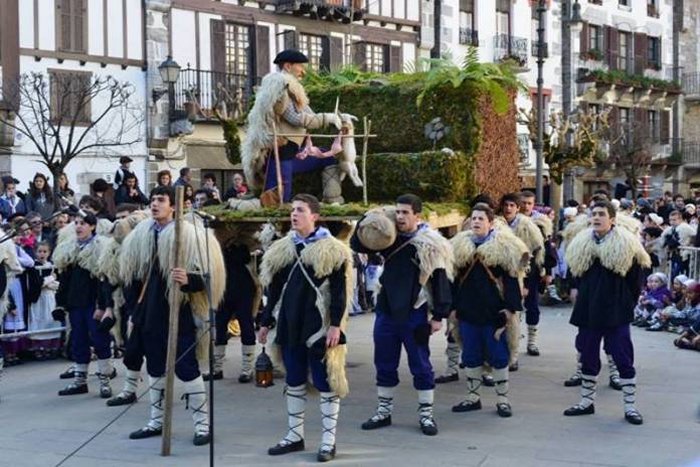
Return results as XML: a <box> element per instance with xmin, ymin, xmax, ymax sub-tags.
<box><xmin>0</xmin><ymin>307</ymin><xmax>700</xmax><ymax>467</ymax></box>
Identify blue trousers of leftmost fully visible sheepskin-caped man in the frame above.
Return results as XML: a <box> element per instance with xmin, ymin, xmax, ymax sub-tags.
<box><xmin>68</xmin><ymin>306</ymin><xmax>112</xmax><ymax>364</ymax></box>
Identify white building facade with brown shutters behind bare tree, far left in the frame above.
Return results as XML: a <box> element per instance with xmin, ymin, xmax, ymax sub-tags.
<box><xmin>0</xmin><ymin>0</ymin><xmax>148</xmax><ymax>194</ymax></box>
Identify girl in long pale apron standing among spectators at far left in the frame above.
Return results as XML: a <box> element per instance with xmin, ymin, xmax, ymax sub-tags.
<box><xmin>27</xmin><ymin>242</ymin><xmax>61</xmax><ymax>360</ymax></box>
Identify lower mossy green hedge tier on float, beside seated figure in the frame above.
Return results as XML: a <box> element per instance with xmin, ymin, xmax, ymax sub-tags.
<box><xmin>293</xmin><ymin>151</ymin><xmax>476</xmax><ymax>203</ymax></box>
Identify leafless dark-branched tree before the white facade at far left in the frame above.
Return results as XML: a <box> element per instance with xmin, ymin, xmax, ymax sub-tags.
<box><xmin>0</xmin><ymin>71</ymin><xmax>145</xmax><ymax>197</ymax></box>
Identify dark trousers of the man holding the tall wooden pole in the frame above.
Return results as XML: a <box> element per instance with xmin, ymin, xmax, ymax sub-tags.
<box><xmin>139</xmin><ymin>322</ymin><xmax>200</xmax><ymax>382</ymax></box>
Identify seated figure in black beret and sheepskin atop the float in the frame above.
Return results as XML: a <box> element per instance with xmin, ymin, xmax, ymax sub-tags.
<box><xmin>241</xmin><ymin>49</ymin><xmax>352</xmax><ymax>206</ymax></box>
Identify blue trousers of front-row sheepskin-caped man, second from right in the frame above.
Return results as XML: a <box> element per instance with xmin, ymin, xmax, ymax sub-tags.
<box><xmin>459</xmin><ymin>321</ymin><xmax>510</xmax><ymax>370</ymax></box>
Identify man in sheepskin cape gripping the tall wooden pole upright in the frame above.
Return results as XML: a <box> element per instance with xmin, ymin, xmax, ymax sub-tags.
<box><xmin>120</xmin><ymin>187</ymin><xmax>226</xmax><ymax>446</ymax></box>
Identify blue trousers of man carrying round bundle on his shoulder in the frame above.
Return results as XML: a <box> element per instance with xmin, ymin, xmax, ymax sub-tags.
<box><xmin>374</xmin><ymin>306</ymin><xmax>435</xmax><ymax>391</ymax></box>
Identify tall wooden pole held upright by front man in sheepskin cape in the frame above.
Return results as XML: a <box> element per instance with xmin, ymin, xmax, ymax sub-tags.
<box><xmin>160</xmin><ymin>186</ymin><xmax>185</xmax><ymax>456</ymax></box>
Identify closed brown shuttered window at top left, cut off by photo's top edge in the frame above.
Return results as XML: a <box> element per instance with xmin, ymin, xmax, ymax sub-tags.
<box><xmin>55</xmin><ymin>0</ymin><xmax>88</xmax><ymax>53</ymax></box>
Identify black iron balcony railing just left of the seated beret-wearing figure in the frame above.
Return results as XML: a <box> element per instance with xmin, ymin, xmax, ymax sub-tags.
<box><xmin>173</xmin><ymin>67</ymin><xmax>253</xmax><ymax>119</ymax></box>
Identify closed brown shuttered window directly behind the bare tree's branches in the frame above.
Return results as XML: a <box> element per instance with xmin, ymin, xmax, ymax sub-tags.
<box><xmin>49</xmin><ymin>70</ymin><xmax>93</xmax><ymax>126</ymax></box>
